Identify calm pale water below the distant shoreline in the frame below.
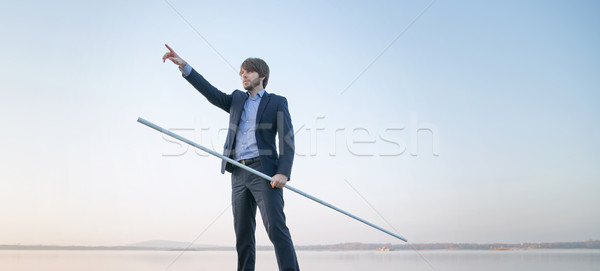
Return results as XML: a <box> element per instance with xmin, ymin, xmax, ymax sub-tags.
<box><xmin>0</xmin><ymin>250</ymin><xmax>600</xmax><ymax>271</ymax></box>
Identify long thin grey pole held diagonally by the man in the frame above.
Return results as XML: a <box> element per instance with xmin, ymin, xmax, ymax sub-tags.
<box><xmin>138</xmin><ymin>118</ymin><xmax>407</xmax><ymax>242</ymax></box>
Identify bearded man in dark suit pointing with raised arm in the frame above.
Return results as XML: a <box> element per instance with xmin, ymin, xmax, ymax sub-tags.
<box><xmin>163</xmin><ymin>44</ymin><xmax>299</xmax><ymax>270</ymax></box>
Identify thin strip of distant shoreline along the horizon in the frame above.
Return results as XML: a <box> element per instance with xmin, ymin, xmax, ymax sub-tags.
<box><xmin>0</xmin><ymin>240</ymin><xmax>600</xmax><ymax>254</ymax></box>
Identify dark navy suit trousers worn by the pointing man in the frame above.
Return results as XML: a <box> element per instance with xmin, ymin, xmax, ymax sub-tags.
<box><xmin>231</xmin><ymin>162</ymin><xmax>300</xmax><ymax>271</ymax></box>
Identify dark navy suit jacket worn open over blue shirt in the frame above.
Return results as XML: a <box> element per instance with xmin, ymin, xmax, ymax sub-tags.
<box><xmin>185</xmin><ymin>69</ymin><xmax>294</xmax><ymax>178</ymax></box>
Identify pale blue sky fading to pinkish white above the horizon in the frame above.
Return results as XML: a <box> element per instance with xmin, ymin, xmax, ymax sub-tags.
<box><xmin>0</xmin><ymin>0</ymin><xmax>600</xmax><ymax>246</ymax></box>
